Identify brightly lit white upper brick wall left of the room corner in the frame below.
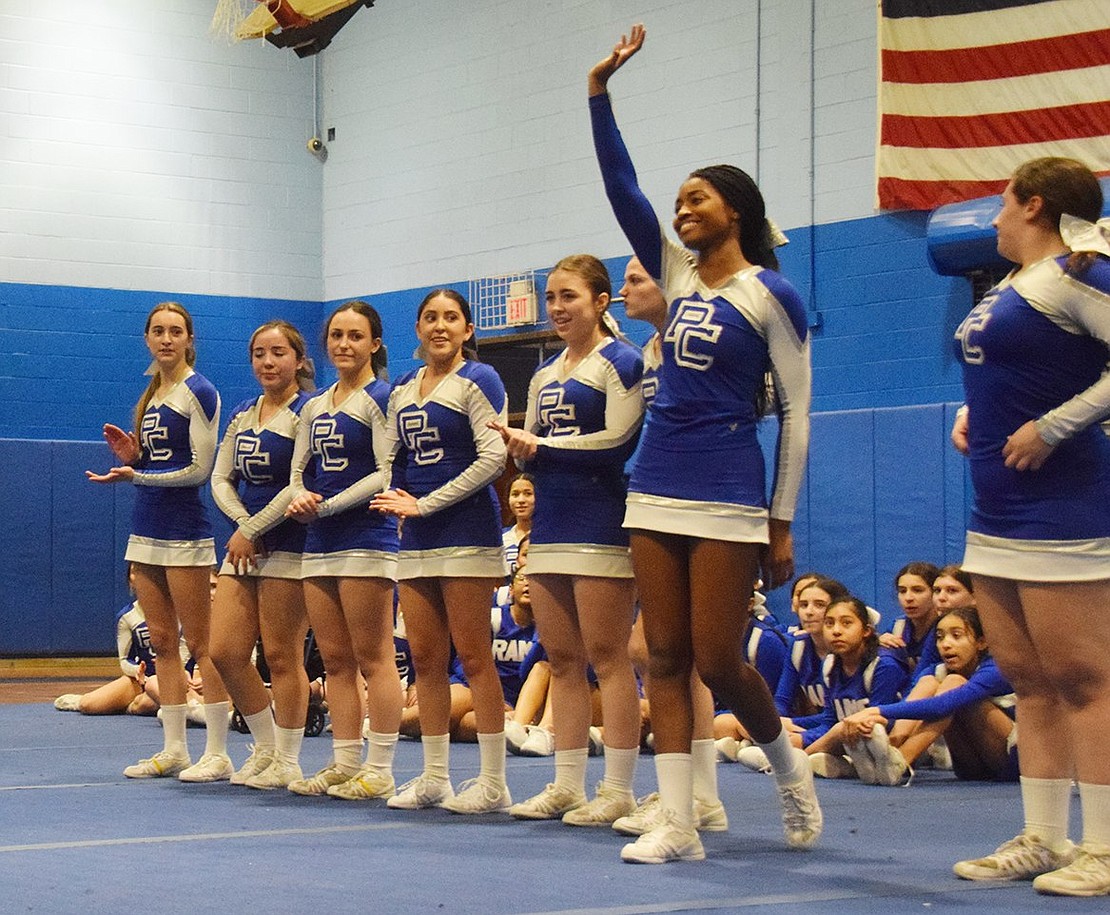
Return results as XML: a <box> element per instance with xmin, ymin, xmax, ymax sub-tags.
<box><xmin>0</xmin><ymin>0</ymin><xmax>322</xmax><ymax>299</ymax></box>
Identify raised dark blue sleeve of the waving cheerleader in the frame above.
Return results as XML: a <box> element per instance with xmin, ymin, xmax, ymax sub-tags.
<box><xmin>589</xmin><ymin>93</ymin><xmax>663</xmax><ymax>279</ymax></box>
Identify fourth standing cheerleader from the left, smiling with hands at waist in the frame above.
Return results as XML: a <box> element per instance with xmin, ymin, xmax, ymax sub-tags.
<box><xmin>371</xmin><ymin>289</ymin><xmax>512</xmax><ymax>814</ymax></box>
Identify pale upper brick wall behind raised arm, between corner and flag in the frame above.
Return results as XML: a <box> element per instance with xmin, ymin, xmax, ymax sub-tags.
<box><xmin>323</xmin><ymin>0</ymin><xmax>875</xmax><ymax>299</ymax></box>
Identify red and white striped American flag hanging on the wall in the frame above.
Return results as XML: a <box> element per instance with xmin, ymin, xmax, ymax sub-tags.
<box><xmin>876</xmin><ymin>0</ymin><xmax>1110</xmax><ymax>210</ymax></box>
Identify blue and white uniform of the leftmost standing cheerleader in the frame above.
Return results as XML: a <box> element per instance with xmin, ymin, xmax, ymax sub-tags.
<box><xmin>124</xmin><ymin>371</ymin><xmax>220</xmax><ymax>566</ymax></box>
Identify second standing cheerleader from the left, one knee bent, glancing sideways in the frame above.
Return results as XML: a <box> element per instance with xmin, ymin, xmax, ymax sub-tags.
<box><xmin>211</xmin><ymin>321</ymin><xmax>315</xmax><ymax>788</ymax></box>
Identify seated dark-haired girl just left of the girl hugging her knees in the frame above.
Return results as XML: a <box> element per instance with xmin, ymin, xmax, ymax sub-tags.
<box><xmin>740</xmin><ymin>596</ymin><xmax>907</xmax><ymax>777</ymax></box>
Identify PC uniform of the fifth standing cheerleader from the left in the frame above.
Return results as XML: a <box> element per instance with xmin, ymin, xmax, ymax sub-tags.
<box><xmin>524</xmin><ymin>336</ymin><xmax>644</xmax><ymax>579</ymax></box>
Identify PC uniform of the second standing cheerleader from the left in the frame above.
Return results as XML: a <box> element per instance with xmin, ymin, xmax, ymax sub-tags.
<box><xmin>212</xmin><ymin>391</ymin><xmax>309</xmax><ymax>579</ymax></box>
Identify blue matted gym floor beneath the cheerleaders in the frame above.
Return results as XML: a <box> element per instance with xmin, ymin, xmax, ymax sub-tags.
<box><xmin>0</xmin><ymin>678</ymin><xmax>1087</xmax><ymax>915</ymax></box>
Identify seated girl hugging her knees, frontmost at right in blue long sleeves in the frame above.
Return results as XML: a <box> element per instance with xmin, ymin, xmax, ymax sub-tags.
<box><xmin>844</xmin><ymin>607</ymin><xmax>1018</xmax><ymax>785</ymax></box>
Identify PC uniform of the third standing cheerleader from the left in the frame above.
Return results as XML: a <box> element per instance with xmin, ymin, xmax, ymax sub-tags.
<box><xmin>290</xmin><ymin>379</ymin><xmax>397</xmax><ymax>581</ymax></box>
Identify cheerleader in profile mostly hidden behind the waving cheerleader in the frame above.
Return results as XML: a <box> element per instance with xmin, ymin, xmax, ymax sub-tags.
<box><xmin>613</xmin><ymin>255</ymin><xmax>728</xmax><ymax>835</ymax></box>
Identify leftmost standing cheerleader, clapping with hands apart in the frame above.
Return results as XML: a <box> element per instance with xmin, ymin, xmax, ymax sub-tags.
<box><xmin>85</xmin><ymin>302</ymin><xmax>227</xmax><ymax>782</ymax></box>
